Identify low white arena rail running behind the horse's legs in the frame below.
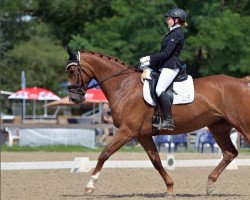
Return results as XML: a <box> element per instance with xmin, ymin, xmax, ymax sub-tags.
<box><xmin>1</xmin><ymin>157</ymin><xmax>250</xmax><ymax>172</ymax></box>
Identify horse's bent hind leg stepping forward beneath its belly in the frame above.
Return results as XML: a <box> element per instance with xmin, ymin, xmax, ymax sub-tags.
<box><xmin>207</xmin><ymin>120</ymin><xmax>238</xmax><ymax>195</ymax></box>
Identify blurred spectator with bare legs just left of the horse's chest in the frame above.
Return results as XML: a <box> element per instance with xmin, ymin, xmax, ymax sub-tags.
<box><xmin>99</xmin><ymin>103</ymin><xmax>113</xmax><ymax>145</ymax></box>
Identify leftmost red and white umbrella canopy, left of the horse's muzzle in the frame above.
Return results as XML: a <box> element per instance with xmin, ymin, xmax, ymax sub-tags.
<box><xmin>8</xmin><ymin>87</ymin><xmax>60</xmax><ymax>100</ymax></box>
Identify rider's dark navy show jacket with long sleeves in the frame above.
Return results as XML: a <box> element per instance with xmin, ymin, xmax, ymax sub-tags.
<box><xmin>150</xmin><ymin>27</ymin><xmax>184</xmax><ymax>70</ymax></box>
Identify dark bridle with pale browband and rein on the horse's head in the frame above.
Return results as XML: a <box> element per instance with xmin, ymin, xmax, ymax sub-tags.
<box><xmin>65</xmin><ymin>51</ymin><xmax>131</xmax><ymax>96</ymax></box>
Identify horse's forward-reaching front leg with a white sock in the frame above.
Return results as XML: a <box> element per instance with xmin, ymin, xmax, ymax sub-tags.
<box><xmin>85</xmin><ymin>127</ymin><xmax>134</xmax><ymax>193</ymax></box>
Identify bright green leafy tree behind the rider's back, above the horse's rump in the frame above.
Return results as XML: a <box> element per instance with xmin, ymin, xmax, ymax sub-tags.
<box><xmin>187</xmin><ymin>10</ymin><xmax>250</xmax><ymax>76</ymax></box>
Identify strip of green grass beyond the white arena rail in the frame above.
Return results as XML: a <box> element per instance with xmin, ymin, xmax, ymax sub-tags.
<box><xmin>1</xmin><ymin>145</ymin><xmax>144</xmax><ymax>152</ymax></box>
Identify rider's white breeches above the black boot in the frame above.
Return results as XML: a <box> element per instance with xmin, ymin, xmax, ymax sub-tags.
<box><xmin>155</xmin><ymin>68</ymin><xmax>180</xmax><ymax>97</ymax></box>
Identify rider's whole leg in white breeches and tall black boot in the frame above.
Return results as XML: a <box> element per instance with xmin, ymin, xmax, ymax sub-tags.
<box><xmin>156</xmin><ymin>68</ymin><xmax>179</xmax><ymax>130</ymax></box>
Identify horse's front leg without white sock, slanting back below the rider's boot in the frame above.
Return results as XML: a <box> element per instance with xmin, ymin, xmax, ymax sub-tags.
<box><xmin>138</xmin><ymin>136</ymin><xmax>174</xmax><ymax>195</ymax></box>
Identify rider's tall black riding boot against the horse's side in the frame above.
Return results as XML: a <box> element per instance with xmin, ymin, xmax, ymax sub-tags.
<box><xmin>158</xmin><ymin>92</ymin><xmax>174</xmax><ymax>130</ymax></box>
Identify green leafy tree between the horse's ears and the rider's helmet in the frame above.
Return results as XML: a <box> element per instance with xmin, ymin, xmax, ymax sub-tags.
<box><xmin>67</xmin><ymin>0</ymin><xmax>175</xmax><ymax>64</ymax></box>
